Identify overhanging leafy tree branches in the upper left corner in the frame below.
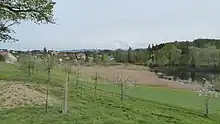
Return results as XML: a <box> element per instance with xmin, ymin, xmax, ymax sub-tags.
<box><xmin>0</xmin><ymin>0</ymin><xmax>55</xmax><ymax>42</ymax></box>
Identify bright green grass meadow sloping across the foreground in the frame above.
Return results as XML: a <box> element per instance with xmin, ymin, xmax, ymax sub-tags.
<box><xmin>0</xmin><ymin>63</ymin><xmax>220</xmax><ymax>124</ymax></box>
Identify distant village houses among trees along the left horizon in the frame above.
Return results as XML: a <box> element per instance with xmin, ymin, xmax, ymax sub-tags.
<box><xmin>0</xmin><ymin>49</ymin><xmax>114</xmax><ymax>64</ymax></box>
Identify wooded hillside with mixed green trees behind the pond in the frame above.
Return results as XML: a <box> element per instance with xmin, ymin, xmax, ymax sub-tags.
<box><xmin>89</xmin><ymin>39</ymin><xmax>220</xmax><ymax>68</ymax></box>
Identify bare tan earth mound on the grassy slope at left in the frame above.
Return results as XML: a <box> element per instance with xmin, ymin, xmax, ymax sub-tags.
<box><xmin>0</xmin><ymin>81</ymin><xmax>55</xmax><ymax>108</ymax></box>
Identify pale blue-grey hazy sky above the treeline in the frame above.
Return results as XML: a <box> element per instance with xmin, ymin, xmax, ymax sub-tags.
<box><xmin>0</xmin><ymin>0</ymin><xmax>220</xmax><ymax>50</ymax></box>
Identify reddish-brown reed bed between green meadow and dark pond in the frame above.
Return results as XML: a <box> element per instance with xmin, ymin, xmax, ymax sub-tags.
<box><xmin>77</xmin><ymin>65</ymin><xmax>200</xmax><ymax>90</ymax></box>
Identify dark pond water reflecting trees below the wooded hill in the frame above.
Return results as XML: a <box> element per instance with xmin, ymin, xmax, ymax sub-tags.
<box><xmin>150</xmin><ymin>67</ymin><xmax>220</xmax><ymax>89</ymax></box>
